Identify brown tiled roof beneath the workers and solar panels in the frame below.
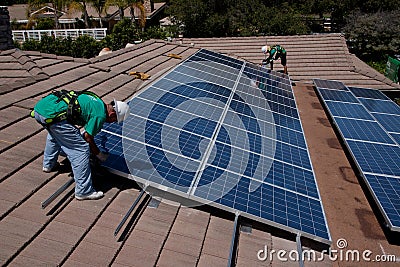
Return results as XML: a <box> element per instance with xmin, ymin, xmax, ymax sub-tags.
<box><xmin>0</xmin><ymin>34</ymin><xmax>400</xmax><ymax>266</ymax></box>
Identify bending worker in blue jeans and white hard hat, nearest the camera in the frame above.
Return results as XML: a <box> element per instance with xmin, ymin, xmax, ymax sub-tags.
<box><xmin>31</xmin><ymin>90</ymin><xmax>129</xmax><ymax>200</ymax></box>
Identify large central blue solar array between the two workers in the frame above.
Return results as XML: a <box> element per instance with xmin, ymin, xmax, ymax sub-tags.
<box><xmin>96</xmin><ymin>50</ymin><xmax>331</xmax><ymax>243</ymax></box>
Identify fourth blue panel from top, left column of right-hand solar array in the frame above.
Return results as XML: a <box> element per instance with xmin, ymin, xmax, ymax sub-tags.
<box><xmin>335</xmin><ymin>118</ymin><xmax>394</xmax><ymax>144</ymax></box>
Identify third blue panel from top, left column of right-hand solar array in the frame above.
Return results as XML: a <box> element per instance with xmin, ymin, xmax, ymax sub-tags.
<box><xmin>325</xmin><ymin>101</ymin><xmax>374</xmax><ymax>120</ymax></box>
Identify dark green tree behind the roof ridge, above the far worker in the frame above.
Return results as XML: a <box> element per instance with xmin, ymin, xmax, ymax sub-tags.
<box><xmin>168</xmin><ymin>0</ymin><xmax>310</xmax><ymax>37</ymax></box>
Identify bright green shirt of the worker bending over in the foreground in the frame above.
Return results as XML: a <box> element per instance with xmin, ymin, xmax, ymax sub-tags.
<box><xmin>34</xmin><ymin>94</ymin><xmax>106</xmax><ymax>136</ymax></box>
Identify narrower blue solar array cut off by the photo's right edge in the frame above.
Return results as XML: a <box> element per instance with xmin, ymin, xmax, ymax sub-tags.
<box><xmin>314</xmin><ymin>79</ymin><xmax>400</xmax><ymax>231</ymax></box>
